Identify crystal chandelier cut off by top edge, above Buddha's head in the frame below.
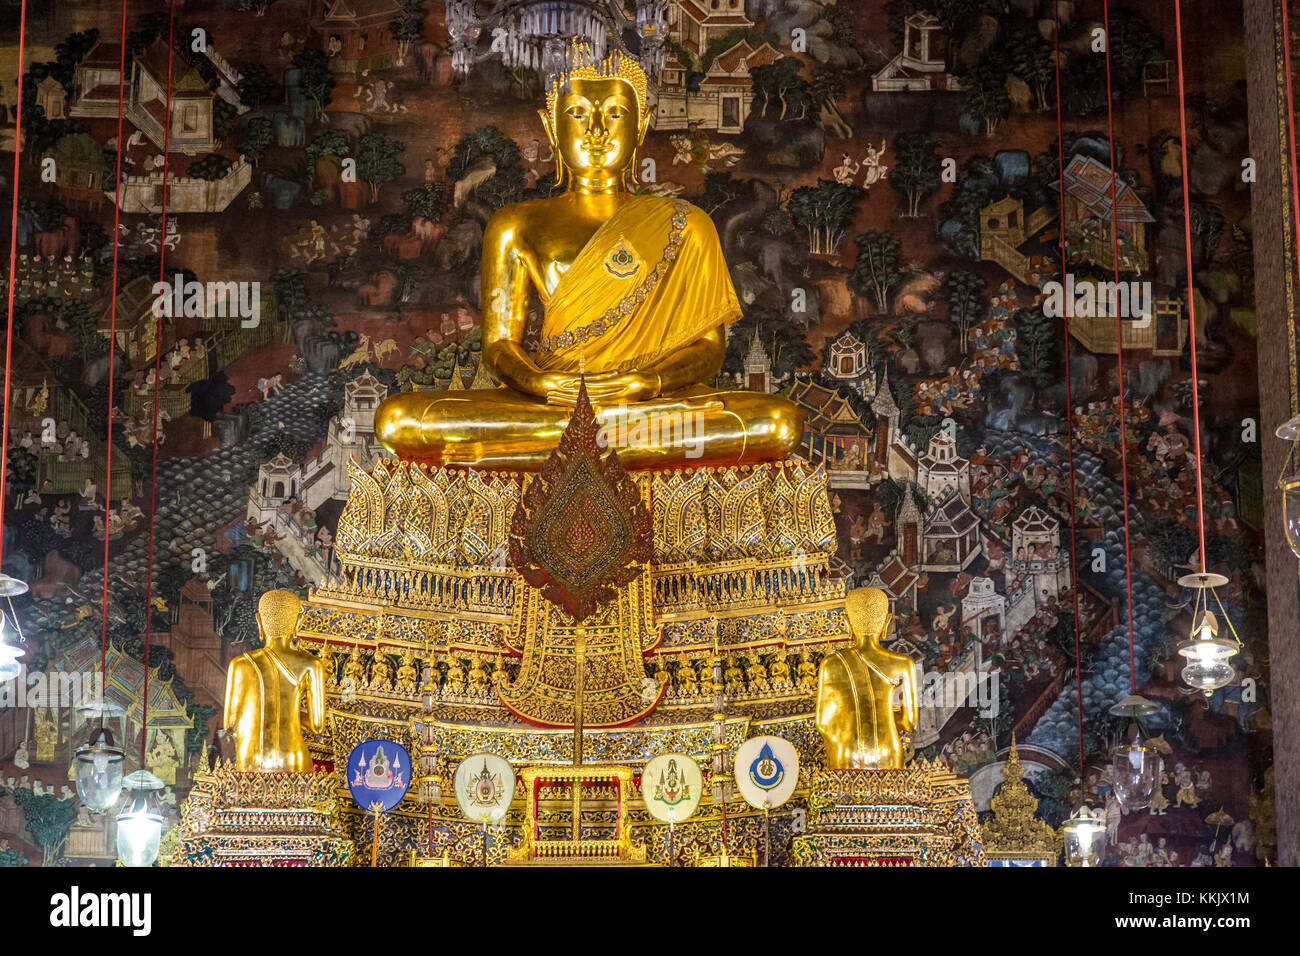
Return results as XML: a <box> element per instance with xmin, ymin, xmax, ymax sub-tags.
<box><xmin>446</xmin><ymin>0</ymin><xmax>668</xmax><ymax>78</ymax></box>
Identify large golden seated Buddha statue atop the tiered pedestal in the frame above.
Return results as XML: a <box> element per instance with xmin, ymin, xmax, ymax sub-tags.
<box><xmin>374</xmin><ymin>44</ymin><xmax>803</xmax><ymax>471</ymax></box>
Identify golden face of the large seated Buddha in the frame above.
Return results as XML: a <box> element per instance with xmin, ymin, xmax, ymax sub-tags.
<box><xmin>547</xmin><ymin>77</ymin><xmax>645</xmax><ymax>179</ymax></box>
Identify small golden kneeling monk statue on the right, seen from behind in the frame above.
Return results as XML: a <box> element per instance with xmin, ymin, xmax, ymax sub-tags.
<box><xmin>816</xmin><ymin>588</ymin><xmax>919</xmax><ymax>770</ymax></box>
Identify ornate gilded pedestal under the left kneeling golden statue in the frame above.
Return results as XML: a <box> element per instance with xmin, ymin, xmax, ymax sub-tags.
<box><xmin>172</xmin><ymin>761</ymin><xmax>352</xmax><ymax>866</ymax></box>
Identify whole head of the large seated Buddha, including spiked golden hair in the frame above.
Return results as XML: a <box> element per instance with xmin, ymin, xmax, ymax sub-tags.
<box><xmin>540</xmin><ymin>53</ymin><xmax>650</xmax><ymax>186</ymax></box>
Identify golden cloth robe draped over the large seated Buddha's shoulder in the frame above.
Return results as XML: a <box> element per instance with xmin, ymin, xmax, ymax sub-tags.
<box><xmin>536</xmin><ymin>195</ymin><xmax>741</xmax><ymax>373</ymax></box>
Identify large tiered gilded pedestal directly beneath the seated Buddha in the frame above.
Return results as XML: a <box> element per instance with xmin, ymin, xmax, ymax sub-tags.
<box><xmin>296</xmin><ymin>460</ymin><xmax>849</xmax><ymax>865</ymax></box>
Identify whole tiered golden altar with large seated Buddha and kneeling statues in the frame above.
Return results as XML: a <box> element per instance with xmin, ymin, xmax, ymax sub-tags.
<box><xmin>172</xmin><ymin>49</ymin><xmax>980</xmax><ymax>865</ymax></box>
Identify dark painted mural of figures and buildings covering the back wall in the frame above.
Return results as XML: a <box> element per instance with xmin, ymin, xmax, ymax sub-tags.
<box><xmin>0</xmin><ymin>0</ymin><xmax>1274</xmax><ymax>866</ymax></box>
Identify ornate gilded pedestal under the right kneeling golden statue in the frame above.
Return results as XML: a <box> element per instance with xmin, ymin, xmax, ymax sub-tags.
<box><xmin>792</xmin><ymin>761</ymin><xmax>987</xmax><ymax>866</ymax></box>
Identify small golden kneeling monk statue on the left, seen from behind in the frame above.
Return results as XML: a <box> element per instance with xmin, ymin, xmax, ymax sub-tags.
<box><xmin>222</xmin><ymin>591</ymin><xmax>325</xmax><ymax>773</ymax></box>
